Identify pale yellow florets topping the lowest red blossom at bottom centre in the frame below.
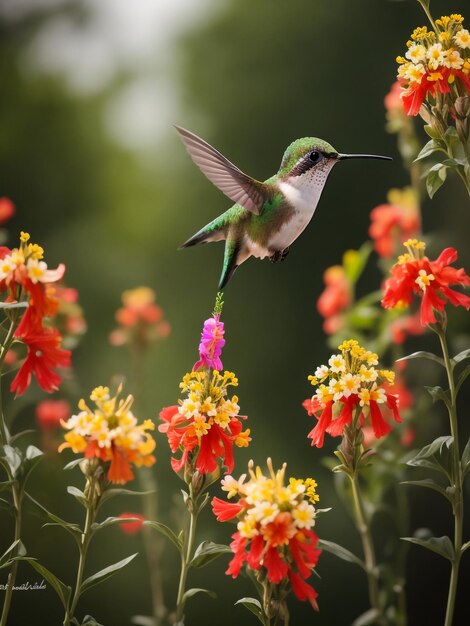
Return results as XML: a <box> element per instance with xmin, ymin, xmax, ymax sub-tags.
<box><xmin>222</xmin><ymin>458</ymin><xmax>319</xmax><ymax>544</ymax></box>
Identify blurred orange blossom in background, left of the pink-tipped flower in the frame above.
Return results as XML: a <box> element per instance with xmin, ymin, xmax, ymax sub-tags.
<box><xmin>109</xmin><ymin>287</ymin><xmax>170</xmax><ymax>346</ymax></box>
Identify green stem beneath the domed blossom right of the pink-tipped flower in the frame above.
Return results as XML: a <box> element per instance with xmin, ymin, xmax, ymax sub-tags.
<box><xmin>349</xmin><ymin>473</ymin><xmax>386</xmax><ymax>625</ymax></box>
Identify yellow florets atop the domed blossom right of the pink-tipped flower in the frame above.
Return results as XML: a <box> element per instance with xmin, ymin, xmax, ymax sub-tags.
<box><xmin>308</xmin><ymin>339</ymin><xmax>395</xmax><ymax>407</ymax></box>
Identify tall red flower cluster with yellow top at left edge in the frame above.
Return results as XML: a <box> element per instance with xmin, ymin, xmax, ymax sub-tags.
<box><xmin>0</xmin><ymin>232</ymin><xmax>70</xmax><ymax>395</ymax></box>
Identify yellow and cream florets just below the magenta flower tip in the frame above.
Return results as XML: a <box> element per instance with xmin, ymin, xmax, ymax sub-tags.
<box><xmin>178</xmin><ymin>369</ymin><xmax>250</xmax><ymax>446</ymax></box>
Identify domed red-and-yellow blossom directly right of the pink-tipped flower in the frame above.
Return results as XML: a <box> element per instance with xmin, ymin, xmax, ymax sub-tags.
<box><xmin>303</xmin><ymin>339</ymin><xmax>402</xmax><ymax>448</ymax></box>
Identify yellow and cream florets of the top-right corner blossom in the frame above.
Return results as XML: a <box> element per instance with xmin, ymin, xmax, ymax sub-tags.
<box><xmin>397</xmin><ymin>14</ymin><xmax>470</xmax><ymax>83</ymax></box>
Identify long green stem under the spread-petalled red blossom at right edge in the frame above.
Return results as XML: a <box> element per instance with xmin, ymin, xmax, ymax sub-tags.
<box><xmin>437</xmin><ymin>325</ymin><xmax>463</xmax><ymax>626</ymax></box>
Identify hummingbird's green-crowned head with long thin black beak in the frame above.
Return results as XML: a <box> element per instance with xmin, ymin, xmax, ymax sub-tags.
<box><xmin>279</xmin><ymin>137</ymin><xmax>391</xmax><ymax>176</ymax></box>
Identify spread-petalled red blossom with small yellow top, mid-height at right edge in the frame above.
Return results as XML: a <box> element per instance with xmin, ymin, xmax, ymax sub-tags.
<box><xmin>382</xmin><ymin>239</ymin><xmax>470</xmax><ymax>326</ymax></box>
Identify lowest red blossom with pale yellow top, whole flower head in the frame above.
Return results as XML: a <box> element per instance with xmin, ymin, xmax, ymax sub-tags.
<box><xmin>212</xmin><ymin>459</ymin><xmax>321</xmax><ymax>610</ymax></box>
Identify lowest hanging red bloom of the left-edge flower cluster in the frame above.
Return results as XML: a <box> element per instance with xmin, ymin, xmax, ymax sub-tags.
<box><xmin>10</xmin><ymin>328</ymin><xmax>70</xmax><ymax>396</ymax></box>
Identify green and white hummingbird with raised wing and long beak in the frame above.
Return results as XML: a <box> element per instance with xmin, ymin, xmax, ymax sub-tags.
<box><xmin>175</xmin><ymin>126</ymin><xmax>392</xmax><ymax>291</ymax></box>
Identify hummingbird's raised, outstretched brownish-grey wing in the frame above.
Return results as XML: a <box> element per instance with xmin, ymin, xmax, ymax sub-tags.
<box><xmin>175</xmin><ymin>126</ymin><xmax>270</xmax><ymax>215</ymax></box>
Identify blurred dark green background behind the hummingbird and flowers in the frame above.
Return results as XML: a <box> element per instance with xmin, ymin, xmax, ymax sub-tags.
<box><xmin>0</xmin><ymin>0</ymin><xmax>470</xmax><ymax>626</ymax></box>
